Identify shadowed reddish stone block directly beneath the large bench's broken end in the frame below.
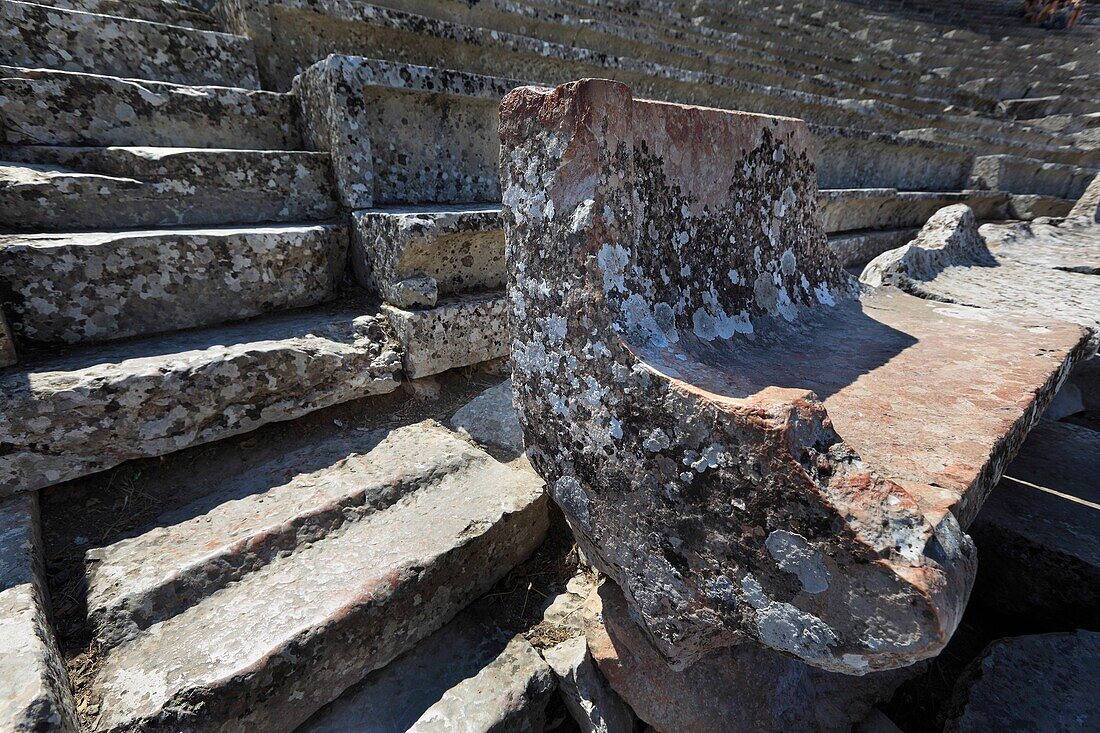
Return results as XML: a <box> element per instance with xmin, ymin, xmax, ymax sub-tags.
<box><xmin>584</xmin><ymin>581</ymin><xmax>909</xmax><ymax>733</ymax></box>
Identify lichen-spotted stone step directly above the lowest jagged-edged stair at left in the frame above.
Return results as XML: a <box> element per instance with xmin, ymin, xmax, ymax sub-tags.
<box><xmin>0</xmin><ymin>225</ymin><xmax>348</xmax><ymax>343</ymax></box>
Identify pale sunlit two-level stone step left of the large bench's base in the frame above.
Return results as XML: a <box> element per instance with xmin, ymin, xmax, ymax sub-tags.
<box><xmin>84</xmin><ymin>420</ymin><xmax>548</xmax><ymax>732</ymax></box>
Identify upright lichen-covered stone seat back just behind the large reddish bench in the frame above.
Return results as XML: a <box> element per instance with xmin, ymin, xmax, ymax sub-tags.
<box><xmin>294</xmin><ymin>55</ymin><xmax>519</xmax><ymax>209</ymax></box>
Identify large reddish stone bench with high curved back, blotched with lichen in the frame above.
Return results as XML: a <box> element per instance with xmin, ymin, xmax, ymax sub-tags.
<box><xmin>502</xmin><ymin>80</ymin><xmax>1086</xmax><ymax>674</ymax></box>
